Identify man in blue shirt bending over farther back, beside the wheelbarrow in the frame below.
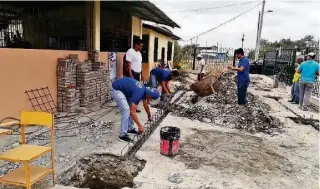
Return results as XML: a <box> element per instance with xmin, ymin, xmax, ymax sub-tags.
<box><xmin>150</xmin><ymin>67</ymin><xmax>179</xmax><ymax>99</ymax></box>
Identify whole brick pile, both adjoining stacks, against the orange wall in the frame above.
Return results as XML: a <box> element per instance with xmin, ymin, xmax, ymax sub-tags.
<box><xmin>58</xmin><ymin>51</ymin><xmax>111</xmax><ymax>111</ymax></box>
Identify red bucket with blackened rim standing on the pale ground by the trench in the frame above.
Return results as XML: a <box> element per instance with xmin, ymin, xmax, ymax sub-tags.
<box><xmin>160</xmin><ymin>126</ymin><xmax>180</xmax><ymax>156</ymax></box>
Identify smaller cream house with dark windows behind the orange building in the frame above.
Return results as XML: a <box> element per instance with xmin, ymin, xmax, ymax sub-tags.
<box><xmin>142</xmin><ymin>23</ymin><xmax>181</xmax><ymax>79</ymax></box>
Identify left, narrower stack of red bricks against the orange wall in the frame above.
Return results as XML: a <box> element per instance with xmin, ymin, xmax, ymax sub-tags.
<box><xmin>57</xmin><ymin>55</ymin><xmax>80</xmax><ymax>112</ymax></box>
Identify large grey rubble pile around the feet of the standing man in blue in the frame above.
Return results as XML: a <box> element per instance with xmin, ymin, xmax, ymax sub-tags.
<box><xmin>175</xmin><ymin>72</ymin><xmax>281</xmax><ymax>134</ymax></box>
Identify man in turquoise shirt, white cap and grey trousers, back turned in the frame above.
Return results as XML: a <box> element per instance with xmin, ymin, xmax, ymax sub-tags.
<box><xmin>297</xmin><ymin>52</ymin><xmax>320</xmax><ymax>111</ymax></box>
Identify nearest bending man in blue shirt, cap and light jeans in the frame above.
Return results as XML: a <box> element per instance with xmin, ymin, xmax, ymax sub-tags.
<box><xmin>111</xmin><ymin>77</ymin><xmax>160</xmax><ymax>142</ymax></box>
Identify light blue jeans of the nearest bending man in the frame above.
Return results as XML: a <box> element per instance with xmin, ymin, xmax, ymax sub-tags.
<box><xmin>111</xmin><ymin>88</ymin><xmax>134</xmax><ymax>137</ymax></box>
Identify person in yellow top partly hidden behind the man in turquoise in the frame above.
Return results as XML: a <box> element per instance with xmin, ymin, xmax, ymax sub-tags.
<box><xmin>289</xmin><ymin>57</ymin><xmax>303</xmax><ymax>104</ymax></box>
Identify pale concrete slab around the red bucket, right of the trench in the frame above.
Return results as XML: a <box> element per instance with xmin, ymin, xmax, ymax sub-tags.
<box><xmin>134</xmin><ymin>112</ymin><xmax>319</xmax><ymax>189</ymax></box>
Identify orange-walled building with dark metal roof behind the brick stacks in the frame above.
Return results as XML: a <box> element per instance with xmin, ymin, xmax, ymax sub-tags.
<box><xmin>0</xmin><ymin>0</ymin><xmax>179</xmax><ymax>118</ymax></box>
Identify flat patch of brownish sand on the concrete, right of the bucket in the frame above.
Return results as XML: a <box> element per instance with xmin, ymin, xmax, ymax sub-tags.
<box><xmin>175</xmin><ymin>129</ymin><xmax>293</xmax><ymax>176</ymax></box>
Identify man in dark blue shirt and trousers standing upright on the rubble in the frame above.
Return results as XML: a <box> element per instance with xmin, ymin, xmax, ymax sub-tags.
<box><xmin>228</xmin><ymin>48</ymin><xmax>250</xmax><ymax>105</ymax></box>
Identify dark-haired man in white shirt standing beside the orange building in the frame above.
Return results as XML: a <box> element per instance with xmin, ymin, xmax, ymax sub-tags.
<box><xmin>123</xmin><ymin>39</ymin><xmax>143</xmax><ymax>81</ymax></box>
